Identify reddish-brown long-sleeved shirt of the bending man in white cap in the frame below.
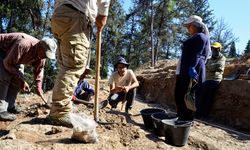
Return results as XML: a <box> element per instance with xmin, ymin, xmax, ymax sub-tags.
<box><xmin>0</xmin><ymin>33</ymin><xmax>46</xmax><ymax>89</ymax></box>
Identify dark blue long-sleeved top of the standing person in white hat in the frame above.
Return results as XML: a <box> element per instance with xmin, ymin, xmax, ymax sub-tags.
<box><xmin>179</xmin><ymin>33</ymin><xmax>209</xmax><ymax>82</ymax></box>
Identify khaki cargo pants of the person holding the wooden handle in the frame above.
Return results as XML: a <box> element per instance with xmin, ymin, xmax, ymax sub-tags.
<box><xmin>50</xmin><ymin>5</ymin><xmax>90</xmax><ymax>117</ymax></box>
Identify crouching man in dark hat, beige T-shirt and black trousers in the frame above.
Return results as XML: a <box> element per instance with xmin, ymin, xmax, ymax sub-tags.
<box><xmin>108</xmin><ymin>57</ymin><xmax>139</xmax><ymax>114</ymax></box>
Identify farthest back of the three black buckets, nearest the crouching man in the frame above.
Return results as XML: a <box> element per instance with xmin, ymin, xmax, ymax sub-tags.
<box><xmin>140</xmin><ymin>108</ymin><xmax>165</xmax><ymax>129</ymax></box>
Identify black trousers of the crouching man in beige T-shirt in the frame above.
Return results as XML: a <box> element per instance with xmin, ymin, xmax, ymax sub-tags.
<box><xmin>108</xmin><ymin>88</ymin><xmax>136</xmax><ymax>110</ymax></box>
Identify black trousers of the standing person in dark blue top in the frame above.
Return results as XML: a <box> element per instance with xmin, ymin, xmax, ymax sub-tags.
<box><xmin>175</xmin><ymin>75</ymin><xmax>196</xmax><ymax>120</ymax></box>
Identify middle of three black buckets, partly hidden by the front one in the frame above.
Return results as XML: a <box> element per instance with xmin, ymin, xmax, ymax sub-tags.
<box><xmin>151</xmin><ymin>112</ymin><xmax>177</xmax><ymax>136</ymax></box>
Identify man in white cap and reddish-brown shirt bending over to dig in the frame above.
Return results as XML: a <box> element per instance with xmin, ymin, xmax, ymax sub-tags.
<box><xmin>0</xmin><ymin>33</ymin><xmax>57</xmax><ymax>120</ymax></box>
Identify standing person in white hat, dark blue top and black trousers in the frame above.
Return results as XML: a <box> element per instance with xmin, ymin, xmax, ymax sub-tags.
<box><xmin>175</xmin><ymin>15</ymin><xmax>210</xmax><ymax>121</ymax></box>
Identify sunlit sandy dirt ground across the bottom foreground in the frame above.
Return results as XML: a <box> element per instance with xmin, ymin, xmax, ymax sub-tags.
<box><xmin>0</xmin><ymin>86</ymin><xmax>250</xmax><ymax>150</ymax></box>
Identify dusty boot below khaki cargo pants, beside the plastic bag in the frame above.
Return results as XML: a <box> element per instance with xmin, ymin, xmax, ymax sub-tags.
<box><xmin>48</xmin><ymin>113</ymin><xmax>73</xmax><ymax>128</ymax></box>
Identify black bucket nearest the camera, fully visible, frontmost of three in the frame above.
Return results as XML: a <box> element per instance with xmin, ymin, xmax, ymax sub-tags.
<box><xmin>162</xmin><ymin>119</ymin><xmax>192</xmax><ymax>146</ymax></box>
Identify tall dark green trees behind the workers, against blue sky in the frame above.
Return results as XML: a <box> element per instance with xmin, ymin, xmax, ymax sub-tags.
<box><xmin>0</xmin><ymin>0</ymin><xmax>239</xmax><ymax>90</ymax></box>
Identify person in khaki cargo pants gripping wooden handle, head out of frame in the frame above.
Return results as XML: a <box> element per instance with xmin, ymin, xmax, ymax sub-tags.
<box><xmin>49</xmin><ymin>0</ymin><xmax>110</xmax><ymax>127</ymax></box>
